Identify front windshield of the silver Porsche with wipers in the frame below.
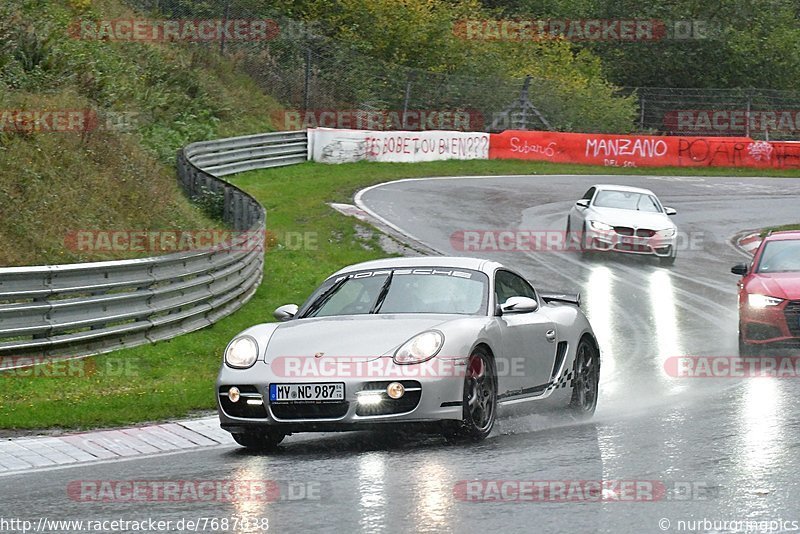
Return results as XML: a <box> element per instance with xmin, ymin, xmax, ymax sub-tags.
<box><xmin>301</xmin><ymin>267</ymin><xmax>489</xmax><ymax>317</ymax></box>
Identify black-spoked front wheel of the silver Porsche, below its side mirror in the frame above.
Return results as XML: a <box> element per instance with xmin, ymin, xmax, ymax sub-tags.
<box><xmin>443</xmin><ymin>347</ymin><xmax>497</xmax><ymax>442</ymax></box>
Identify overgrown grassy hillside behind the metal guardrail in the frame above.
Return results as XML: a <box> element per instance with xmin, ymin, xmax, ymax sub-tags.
<box><xmin>0</xmin><ymin>0</ymin><xmax>277</xmax><ymax>266</ymax></box>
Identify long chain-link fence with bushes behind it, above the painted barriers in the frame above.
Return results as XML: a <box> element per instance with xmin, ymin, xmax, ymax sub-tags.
<box><xmin>122</xmin><ymin>0</ymin><xmax>800</xmax><ymax>139</ymax></box>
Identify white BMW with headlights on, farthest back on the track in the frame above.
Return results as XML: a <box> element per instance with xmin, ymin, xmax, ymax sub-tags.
<box><xmin>567</xmin><ymin>184</ymin><xmax>678</xmax><ymax>265</ymax></box>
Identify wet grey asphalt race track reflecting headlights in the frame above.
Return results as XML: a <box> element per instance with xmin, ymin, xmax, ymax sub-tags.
<box><xmin>0</xmin><ymin>176</ymin><xmax>800</xmax><ymax>533</ymax></box>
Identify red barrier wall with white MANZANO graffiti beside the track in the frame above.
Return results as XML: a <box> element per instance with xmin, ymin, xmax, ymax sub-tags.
<box><xmin>489</xmin><ymin>130</ymin><xmax>800</xmax><ymax>169</ymax></box>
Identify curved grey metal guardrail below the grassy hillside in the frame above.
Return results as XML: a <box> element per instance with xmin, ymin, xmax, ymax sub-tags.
<box><xmin>0</xmin><ymin>132</ymin><xmax>307</xmax><ymax>369</ymax></box>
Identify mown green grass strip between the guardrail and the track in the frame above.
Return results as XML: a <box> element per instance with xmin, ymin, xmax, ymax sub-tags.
<box><xmin>0</xmin><ymin>161</ymin><xmax>800</xmax><ymax>429</ymax></box>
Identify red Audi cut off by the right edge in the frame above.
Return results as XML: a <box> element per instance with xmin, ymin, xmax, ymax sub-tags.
<box><xmin>731</xmin><ymin>231</ymin><xmax>800</xmax><ymax>356</ymax></box>
